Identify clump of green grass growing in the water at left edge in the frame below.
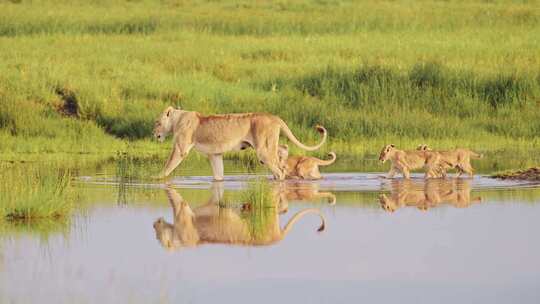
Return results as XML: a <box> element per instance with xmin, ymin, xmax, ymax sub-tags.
<box><xmin>0</xmin><ymin>164</ymin><xmax>74</xmax><ymax>221</ymax></box>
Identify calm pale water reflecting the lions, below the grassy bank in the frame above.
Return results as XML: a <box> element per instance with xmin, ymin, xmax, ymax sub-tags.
<box><xmin>0</xmin><ymin>173</ymin><xmax>540</xmax><ymax>303</ymax></box>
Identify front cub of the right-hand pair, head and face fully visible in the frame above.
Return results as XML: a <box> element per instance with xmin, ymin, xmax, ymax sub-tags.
<box><xmin>379</xmin><ymin>145</ymin><xmax>440</xmax><ymax>179</ymax></box>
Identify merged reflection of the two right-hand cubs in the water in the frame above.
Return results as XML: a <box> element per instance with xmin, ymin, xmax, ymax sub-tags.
<box><xmin>379</xmin><ymin>179</ymin><xmax>482</xmax><ymax>212</ymax></box>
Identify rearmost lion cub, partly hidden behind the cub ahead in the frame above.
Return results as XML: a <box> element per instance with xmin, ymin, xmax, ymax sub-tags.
<box><xmin>416</xmin><ymin>144</ymin><xmax>484</xmax><ymax>177</ymax></box>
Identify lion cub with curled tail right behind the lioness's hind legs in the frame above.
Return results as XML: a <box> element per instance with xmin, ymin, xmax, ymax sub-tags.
<box><xmin>278</xmin><ymin>145</ymin><xmax>336</xmax><ymax>179</ymax></box>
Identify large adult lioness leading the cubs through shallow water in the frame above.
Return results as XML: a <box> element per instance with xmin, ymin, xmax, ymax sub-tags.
<box><xmin>154</xmin><ymin>107</ymin><xmax>327</xmax><ymax>180</ymax></box>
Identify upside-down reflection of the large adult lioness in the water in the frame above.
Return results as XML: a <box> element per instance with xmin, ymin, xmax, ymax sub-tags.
<box><xmin>153</xmin><ymin>183</ymin><xmax>325</xmax><ymax>250</ymax></box>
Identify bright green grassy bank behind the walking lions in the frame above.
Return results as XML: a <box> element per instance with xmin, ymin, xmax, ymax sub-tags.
<box><xmin>0</xmin><ymin>0</ymin><xmax>540</xmax><ymax>166</ymax></box>
